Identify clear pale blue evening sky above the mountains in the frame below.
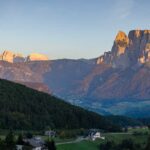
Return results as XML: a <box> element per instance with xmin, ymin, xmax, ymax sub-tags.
<box><xmin>0</xmin><ymin>0</ymin><xmax>150</xmax><ymax>59</ymax></box>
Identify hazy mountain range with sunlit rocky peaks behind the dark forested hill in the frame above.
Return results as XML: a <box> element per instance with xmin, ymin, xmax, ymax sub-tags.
<box><xmin>0</xmin><ymin>30</ymin><xmax>150</xmax><ymax>117</ymax></box>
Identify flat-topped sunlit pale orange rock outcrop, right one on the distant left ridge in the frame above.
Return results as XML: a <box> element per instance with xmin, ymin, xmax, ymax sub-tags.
<box><xmin>27</xmin><ymin>53</ymin><xmax>48</xmax><ymax>61</ymax></box>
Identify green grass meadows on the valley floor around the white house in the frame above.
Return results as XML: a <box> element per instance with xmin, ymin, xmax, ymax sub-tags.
<box><xmin>0</xmin><ymin>128</ymin><xmax>150</xmax><ymax>150</ymax></box>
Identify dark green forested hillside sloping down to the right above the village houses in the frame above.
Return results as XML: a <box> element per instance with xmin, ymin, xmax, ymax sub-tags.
<box><xmin>0</xmin><ymin>80</ymin><xmax>119</xmax><ymax>130</ymax></box>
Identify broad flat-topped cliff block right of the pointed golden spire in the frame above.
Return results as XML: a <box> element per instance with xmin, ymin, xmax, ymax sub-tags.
<box><xmin>127</xmin><ymin>30</ymin><xmax>150</xmax><ymax>65</ymax></box>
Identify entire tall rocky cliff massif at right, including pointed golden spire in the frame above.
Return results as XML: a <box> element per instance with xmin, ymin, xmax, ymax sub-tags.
<box><xmin>97</xmin><ymin>30</ymin><xmax>150</xmax><ymax>68</ymax></box>
